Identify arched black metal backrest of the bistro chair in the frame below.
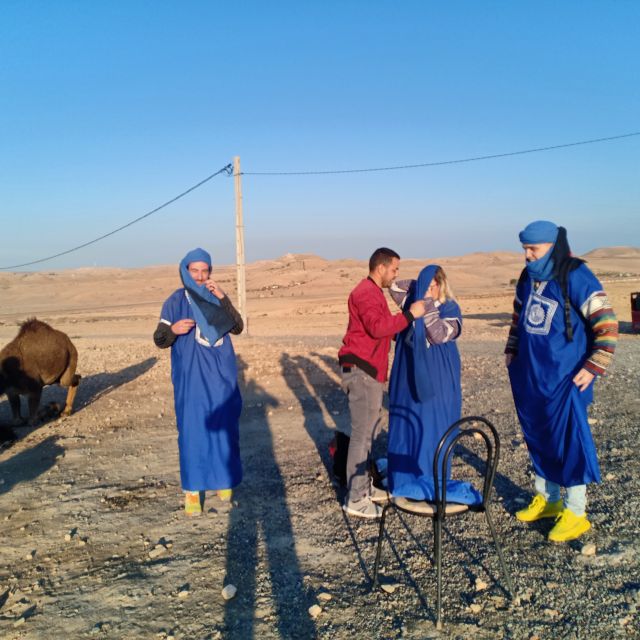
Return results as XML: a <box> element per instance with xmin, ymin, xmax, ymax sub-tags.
<box><xmin>433</xmin><ymin>416</ymin><xmax>500</xmax><ymax>514</ymax></box>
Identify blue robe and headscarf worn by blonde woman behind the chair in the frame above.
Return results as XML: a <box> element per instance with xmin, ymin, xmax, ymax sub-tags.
<box><xmin>388</xmin><ymin>265</ymin><xmax>477</xmax><ymax>503</ymax></box>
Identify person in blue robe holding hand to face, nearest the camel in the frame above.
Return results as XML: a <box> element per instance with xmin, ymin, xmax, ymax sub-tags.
<box><xmin>154</xmin><ymin>249</ymin><xmax>243</xmax><ymax>515</ymax></box>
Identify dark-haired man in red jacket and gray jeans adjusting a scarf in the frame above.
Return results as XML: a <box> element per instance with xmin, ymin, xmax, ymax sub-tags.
<box><xmin>338</xmin><ymin>247</ymin><xmax>425</xmax><ymax>518</ymax></box>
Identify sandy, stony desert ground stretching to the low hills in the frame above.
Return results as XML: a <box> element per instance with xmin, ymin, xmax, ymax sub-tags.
<box><xmin>0</xmin><ymin>248</ymin><xmax>640</xmax><ymax>640</ymax></box>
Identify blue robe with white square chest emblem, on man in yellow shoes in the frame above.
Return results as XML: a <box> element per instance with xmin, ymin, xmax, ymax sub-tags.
<box><xmin>509</xmin><ymin>264</ymin><xmax>602</xmax><ymax>487</ymax></box>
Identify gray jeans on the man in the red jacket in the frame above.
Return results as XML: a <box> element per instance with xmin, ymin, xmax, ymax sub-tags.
<box><xmin>342</xmin><ymin>367</ymin><xmax>384</xmax><ymax>502</ymax></box>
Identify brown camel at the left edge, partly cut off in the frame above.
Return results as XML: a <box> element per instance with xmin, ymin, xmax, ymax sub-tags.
<box><xmin>0</xmin><ymin>318</ymin><xmax>80</xmax><ymax>425</ymax></box>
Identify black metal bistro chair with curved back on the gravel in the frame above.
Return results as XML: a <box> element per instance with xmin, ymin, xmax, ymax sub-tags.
<box><xmin>373</xmin><ymin>416</ymin><xmax>513</xmax><ymax>629</ymax></box>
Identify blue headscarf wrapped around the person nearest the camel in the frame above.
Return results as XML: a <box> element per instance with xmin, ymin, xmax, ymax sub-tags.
<box><xmin>180</xmin><ymin>248</ymin><xmax>235</xmax><ymax>344</ymax></box>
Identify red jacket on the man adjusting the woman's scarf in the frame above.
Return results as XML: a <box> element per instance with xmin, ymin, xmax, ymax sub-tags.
<box><xmin>338</xmin><ymin>278</ymin><xmax>413</xmax><ymax>382</ymax></box>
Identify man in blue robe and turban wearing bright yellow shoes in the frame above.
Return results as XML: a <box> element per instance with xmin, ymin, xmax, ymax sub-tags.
<box><xmin>505</xmin><ymin>220</ymin><xmax>617</xmax><ymax>542</ymax></box>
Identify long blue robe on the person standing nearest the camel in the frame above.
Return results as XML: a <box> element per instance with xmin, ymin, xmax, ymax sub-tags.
<box><xmin>161</xmin><ymin>289</ymin><xmax>242</xmax><ymax>491</ymax></box>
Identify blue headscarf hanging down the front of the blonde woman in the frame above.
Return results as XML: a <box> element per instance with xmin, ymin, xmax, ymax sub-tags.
<box><xmin>399</xmin><ymin>264</ymin><xmax>459</xmax><ymax>402</ymax></box>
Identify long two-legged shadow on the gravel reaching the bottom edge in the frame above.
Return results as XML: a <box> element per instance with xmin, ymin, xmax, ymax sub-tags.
<box><xmin>224</xmin><ymin>357</ymin><xmax>316</xmax><ymax>640</ymax></box>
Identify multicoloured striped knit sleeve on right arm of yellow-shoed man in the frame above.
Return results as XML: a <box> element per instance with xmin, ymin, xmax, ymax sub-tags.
<box><xmin>580</xmin><ymin>291</ymin><xmax>618</xmax><ymax>376</ymax></box>
